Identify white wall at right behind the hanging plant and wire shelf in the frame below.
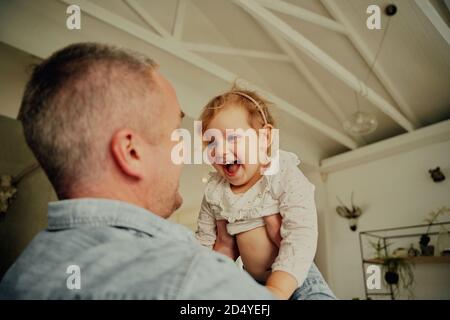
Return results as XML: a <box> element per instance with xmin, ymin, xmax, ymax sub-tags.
<box><xmin>321</xmin><ymin>137</ymin><xmax>450</xmax><ymax>299</ymax></box>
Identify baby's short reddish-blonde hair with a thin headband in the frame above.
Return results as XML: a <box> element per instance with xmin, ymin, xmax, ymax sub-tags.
<box><xmin>199</xmin><ymin>85</ymin><xmax>275</xmax><ymax>134</ymax></box>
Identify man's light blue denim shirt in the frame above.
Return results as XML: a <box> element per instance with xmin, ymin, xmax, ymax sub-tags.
<box><xmin>0</xmin><ymin>199</ymin><xmax>273</xmax><ymax>299</ymax></box>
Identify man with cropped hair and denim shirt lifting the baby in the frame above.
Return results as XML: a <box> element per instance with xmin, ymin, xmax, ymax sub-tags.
<box><xmin>0</xmin><ymin>43</ymin><xmax>332</xmax><ymax>299</ymax></box>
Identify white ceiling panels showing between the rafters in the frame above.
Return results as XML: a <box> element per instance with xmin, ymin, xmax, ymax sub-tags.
<box><xmin>87</xmin><ymin>0</ymin><xmax>450</xmax><ymax>157</ymax></box>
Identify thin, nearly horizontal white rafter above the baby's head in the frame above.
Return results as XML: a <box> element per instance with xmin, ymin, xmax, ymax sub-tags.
<box><xmin>182</xmin><ymin>42</ymin><xmax>290</xmax><ymax>62</ymax></box>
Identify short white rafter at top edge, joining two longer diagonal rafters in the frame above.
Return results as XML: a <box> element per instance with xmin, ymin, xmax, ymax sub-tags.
<box><xmin>258</xmin><ymin>0</ymin><xmax>347</xmax><ymax>33</ymax></box>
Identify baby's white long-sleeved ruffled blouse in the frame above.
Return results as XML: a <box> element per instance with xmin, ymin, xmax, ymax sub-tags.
<box><xmin>196</xmin><ymin>150</ymin><xmax>318</xmax><ymax>286</ymax></box>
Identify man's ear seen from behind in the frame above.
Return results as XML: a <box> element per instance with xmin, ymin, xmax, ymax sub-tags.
<box><xmin>111</xmin><ymin>129</ymin><xmax>144</xmax><ymax>179</ymax></box>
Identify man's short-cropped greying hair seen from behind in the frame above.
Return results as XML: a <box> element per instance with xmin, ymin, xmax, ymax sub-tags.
<box><xmin>19</xmin><ymin>43</ymin><xmax>159</xmax><ymax>199</ymax></box>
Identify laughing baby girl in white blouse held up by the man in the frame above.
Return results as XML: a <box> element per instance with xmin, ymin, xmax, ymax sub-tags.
<box><xmin>196</xmin><ymin>88</ymin><xmax>317</xmax><ymax>299</ymax></box>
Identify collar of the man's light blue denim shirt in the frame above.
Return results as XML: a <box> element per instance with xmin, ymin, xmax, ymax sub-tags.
<box><xmin>48</xmin><ymin>198</ymin><xmax>194</xmax><ymax>240</ymax></box>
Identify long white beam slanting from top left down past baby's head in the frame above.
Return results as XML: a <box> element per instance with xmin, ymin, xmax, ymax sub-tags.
<box><xmin>60</xmin><ymin>0</ymin><xmax>358</xmax><ymax>149</ymax></box>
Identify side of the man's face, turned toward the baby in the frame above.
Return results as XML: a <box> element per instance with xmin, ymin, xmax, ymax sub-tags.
<box><xmin>143</xmin><ymin>72</ymin><xmax>184</xmax><ymax>218</ymax></box>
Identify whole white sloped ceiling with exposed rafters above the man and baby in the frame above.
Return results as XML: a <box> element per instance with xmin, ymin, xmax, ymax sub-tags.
<box><xmin>0</xmin><ymin>0</ymin><xmax>450</xmax><ymax>164</ymax></box>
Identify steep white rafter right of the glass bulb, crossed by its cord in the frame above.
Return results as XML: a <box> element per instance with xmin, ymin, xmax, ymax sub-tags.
<box><xmin>321</xmin><ymin>0</ymin><xmax>420</xmax><ymax>127</ymax></box>
